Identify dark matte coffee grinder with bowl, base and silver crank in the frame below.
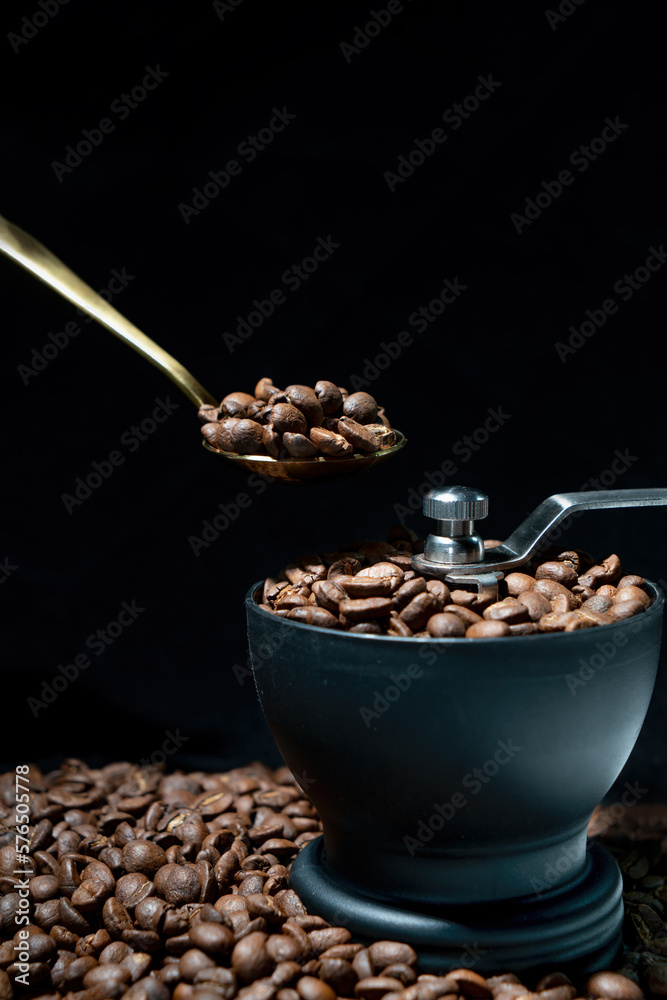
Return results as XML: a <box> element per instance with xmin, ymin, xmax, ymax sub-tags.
<box><xmin>246</xmin><ymin>490</ymin><xmax>665</xmax><ymax>973</ymax></box>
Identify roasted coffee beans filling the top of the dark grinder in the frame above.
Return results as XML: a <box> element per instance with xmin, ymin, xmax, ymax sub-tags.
<box><xmin>261</xmin><ymin>525</ymin><xmax>651</xmax><ymax>639</ymax></box>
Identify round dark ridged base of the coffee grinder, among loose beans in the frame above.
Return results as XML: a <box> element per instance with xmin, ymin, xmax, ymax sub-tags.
<box><xmin>290</xmin><ymin>837</ymin><xmax>623</xmax><ymax>974</ymax></box>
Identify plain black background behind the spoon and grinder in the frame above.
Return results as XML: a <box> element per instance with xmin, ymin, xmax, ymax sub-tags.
<box><xmin>0</xmin><ymin>0</ymin><xmax>667</xmax><ymax>799</ymax></box>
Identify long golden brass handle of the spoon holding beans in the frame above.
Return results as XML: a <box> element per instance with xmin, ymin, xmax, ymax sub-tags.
<box><xmin>0</xmin><ymin>215</ymin><xmax>218</xmax><ymax>406</ymax></box>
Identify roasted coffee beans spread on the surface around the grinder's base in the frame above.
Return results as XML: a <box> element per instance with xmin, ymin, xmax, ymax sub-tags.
<box><xmin>0</xmin><ymin>759</ymin><xmax>667</xmax><ymax>1000</ymax></box>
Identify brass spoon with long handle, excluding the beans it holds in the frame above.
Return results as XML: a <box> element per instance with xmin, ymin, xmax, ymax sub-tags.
<box><xmin>0</xmin><ymin>216</ymin><xmax>406</xmax><ymax>485</ymax></box>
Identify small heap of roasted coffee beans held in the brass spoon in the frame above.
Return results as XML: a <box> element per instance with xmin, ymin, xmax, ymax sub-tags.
<box><xmin>199</xmin><ymin>378</ymin><xmax>396</xmax><ymax>460</ymax></box>
